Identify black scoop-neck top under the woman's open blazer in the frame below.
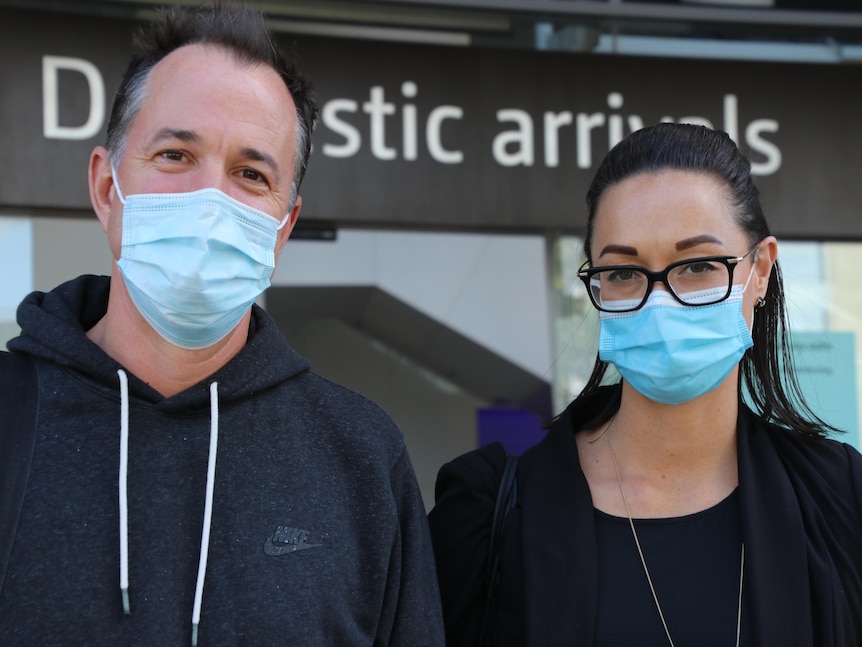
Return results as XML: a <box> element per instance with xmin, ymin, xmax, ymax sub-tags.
<box><xmin>595</xmin><ymin>490</ymin><xmax>753</xmax><ymax>647</ymax></box>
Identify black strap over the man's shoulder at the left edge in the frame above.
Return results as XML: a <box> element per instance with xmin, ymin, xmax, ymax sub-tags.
<box><xmin>0</xmin><ymin>352</ymin><xmax>38</xmax><ymax>592</ymax></box>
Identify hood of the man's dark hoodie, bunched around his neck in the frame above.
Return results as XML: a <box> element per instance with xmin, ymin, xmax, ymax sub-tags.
<box><xmin>7</xmin><ymin>275</ymin><xmax>309</xmax><ymax>412</ymax></box>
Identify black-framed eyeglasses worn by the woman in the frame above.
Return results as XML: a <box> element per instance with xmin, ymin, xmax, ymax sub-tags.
<box><xmin>578</xmin><ymin>245</ymin><xmax>758</xmax><ymax>312</ymax></box>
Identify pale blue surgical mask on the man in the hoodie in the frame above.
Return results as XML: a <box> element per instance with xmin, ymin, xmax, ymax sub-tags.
<box><xmin>114</xmin><ymin>174</ymin><xmax>287</xmax><ymax>350</ymax></box>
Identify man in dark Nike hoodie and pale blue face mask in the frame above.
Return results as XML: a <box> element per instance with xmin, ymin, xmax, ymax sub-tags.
<box><xmin>0</xmin><ymin>5</ymin><xmax>443</xmax><ymax>646</ymax></box>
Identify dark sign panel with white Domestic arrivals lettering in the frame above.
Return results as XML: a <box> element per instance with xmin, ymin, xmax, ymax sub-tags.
<box><xmin>0</xmin><ymin>10</ymin><xmax>862</xmax><ymax>238</ymax></box>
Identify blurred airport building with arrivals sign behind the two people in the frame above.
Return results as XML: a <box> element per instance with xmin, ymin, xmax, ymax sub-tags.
<box><xmin>0</xmin><ymin>0</ymin><xmax>862</xmax><ymax>506</ymax></box>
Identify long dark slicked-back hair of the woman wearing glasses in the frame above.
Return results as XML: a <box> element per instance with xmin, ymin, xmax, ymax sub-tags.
<box><xmin>578</xmin><ymin>123</ymin><xmax>836</xmax><ymax>436</ymax></box>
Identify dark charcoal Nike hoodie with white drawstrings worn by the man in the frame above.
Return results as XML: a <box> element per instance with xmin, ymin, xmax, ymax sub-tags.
<box><xmin>0</xmin><ymin>276</ymin><xmax>443</xmax><ymax>647</ymax></box>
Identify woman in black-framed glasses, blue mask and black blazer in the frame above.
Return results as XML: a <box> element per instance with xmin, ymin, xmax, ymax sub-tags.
<box><xmin>429</xmin><ymin>124</ymin><xmax>862</xmax><ymax>647</ymax></box>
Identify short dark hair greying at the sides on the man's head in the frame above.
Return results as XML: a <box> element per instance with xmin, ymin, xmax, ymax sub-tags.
<box><xmin>106</xmin><ymin>0</ymin><xmax>319</xmax><ymax>208</ymax></box>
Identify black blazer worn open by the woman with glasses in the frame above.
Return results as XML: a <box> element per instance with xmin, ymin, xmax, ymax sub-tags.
<box><xmin>429</xmin><ymin>387</ymin><xmax>862</xmax><ymax>647</ymax></box>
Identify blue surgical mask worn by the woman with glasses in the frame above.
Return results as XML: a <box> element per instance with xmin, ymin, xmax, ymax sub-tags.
<box><xmin>599</xmin><ymin>284</ymin><xmax>754</xmax><ymax>404</ymax></box>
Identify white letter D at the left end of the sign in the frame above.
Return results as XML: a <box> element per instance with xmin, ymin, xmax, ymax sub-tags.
<box><xmin>42</xmin><ymin>56</ymin><xmax>105</xmax><ymax>140</ymax></box>
